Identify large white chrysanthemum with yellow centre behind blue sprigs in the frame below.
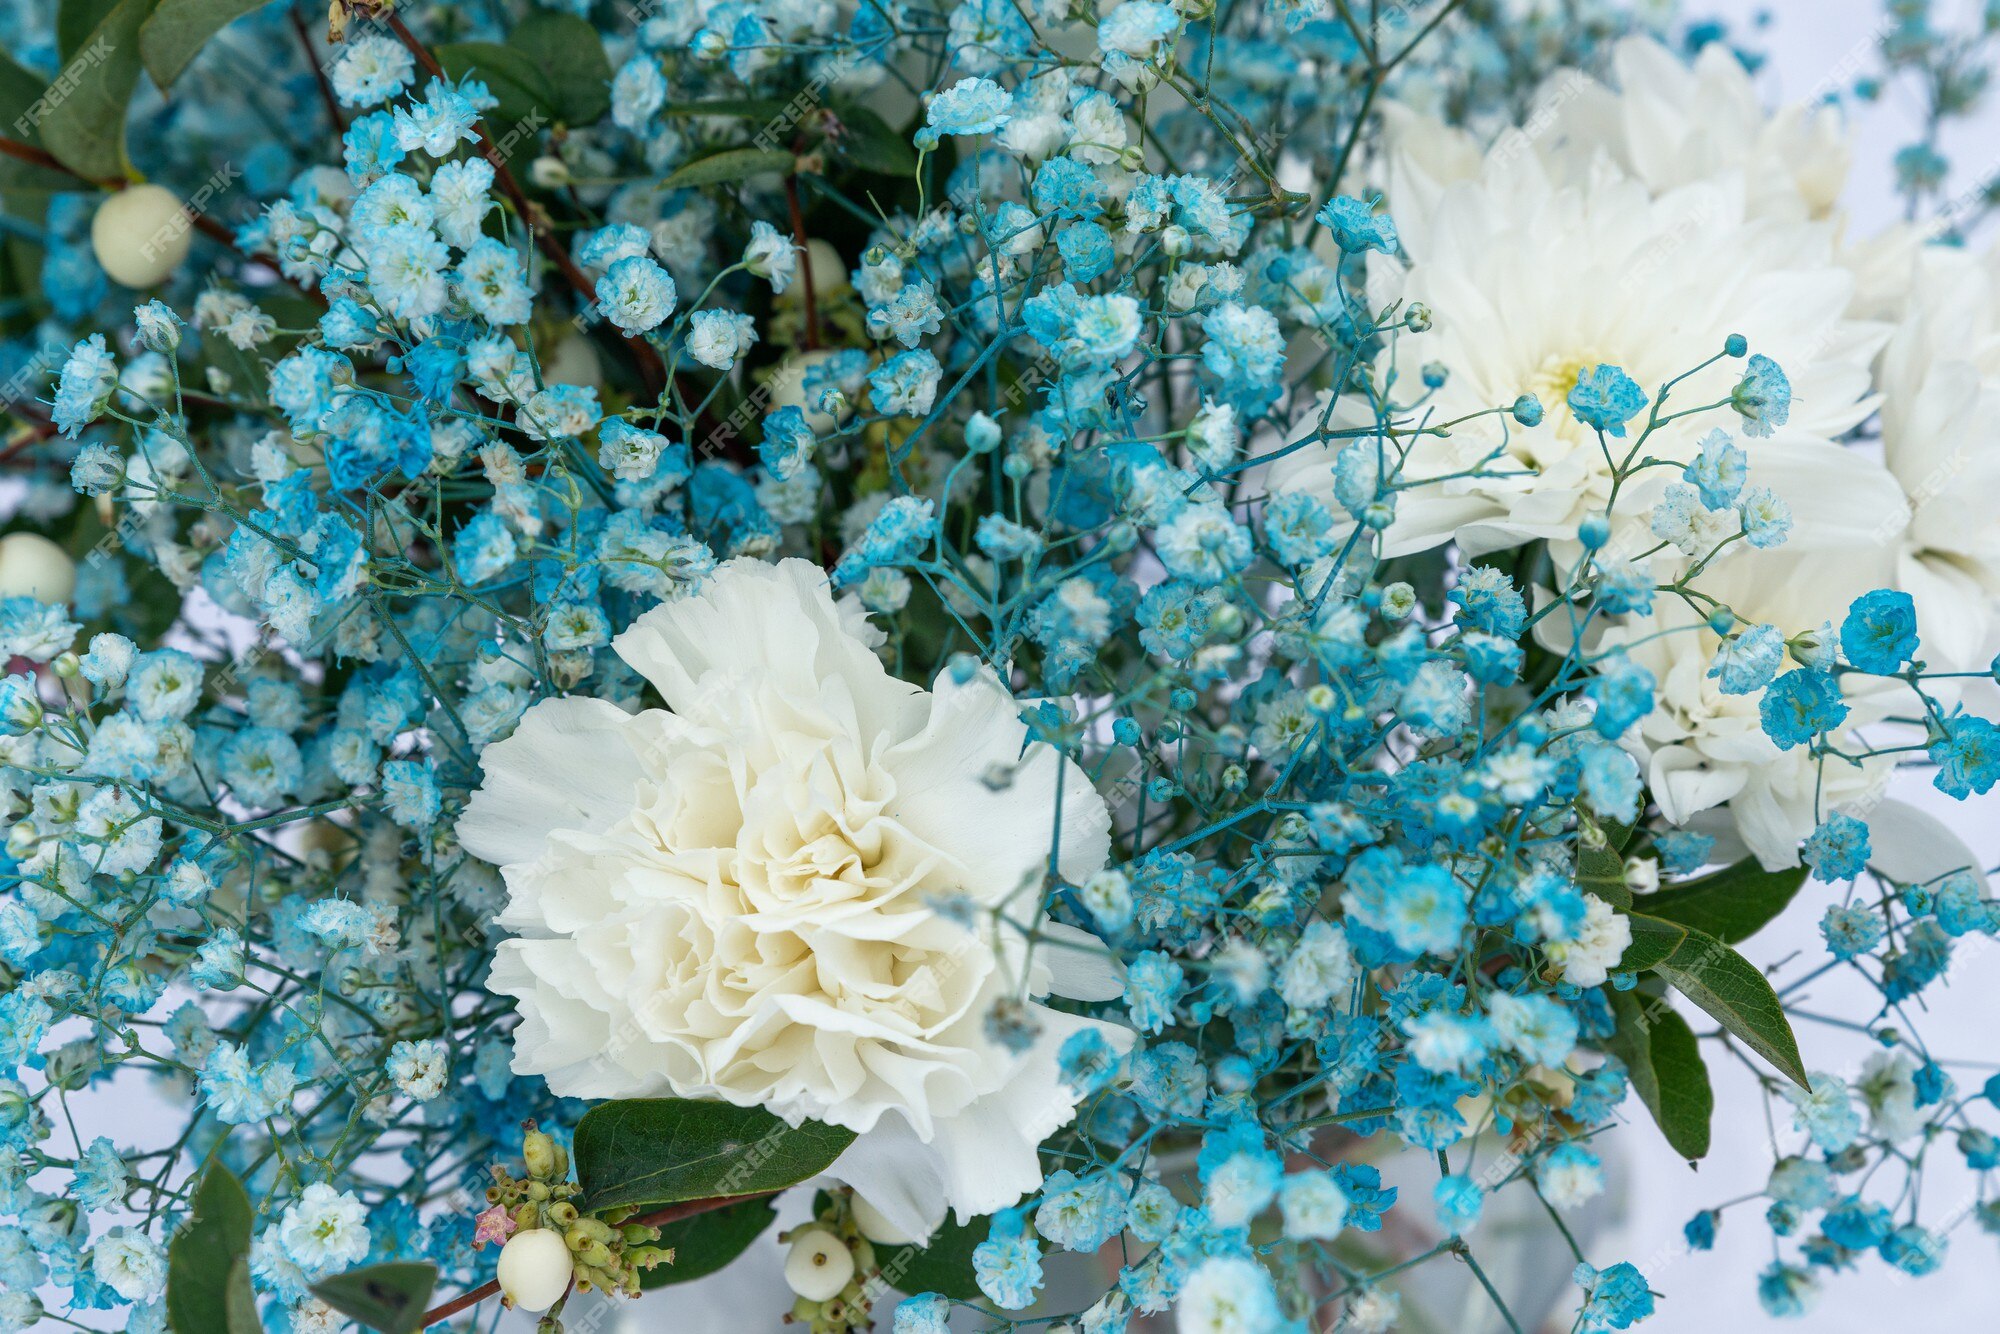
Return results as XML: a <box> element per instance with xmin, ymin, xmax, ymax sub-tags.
<box><xmin>1276</xmin><ymin>154</ymin><xmax>1894</xmax><ymax>554</ymax></box>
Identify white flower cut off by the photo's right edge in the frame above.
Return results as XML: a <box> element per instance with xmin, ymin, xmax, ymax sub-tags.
<box><xmin>1860</xmin><ymin>246</ymin><xmax>2000</xmax><ymax>668</ymax></box>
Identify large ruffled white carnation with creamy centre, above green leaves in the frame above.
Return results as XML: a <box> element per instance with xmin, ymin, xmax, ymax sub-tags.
<box><xmin>458</xmin><ymin>560</ymin><xmax>1122</xmax><ymax>1236</ymax></box>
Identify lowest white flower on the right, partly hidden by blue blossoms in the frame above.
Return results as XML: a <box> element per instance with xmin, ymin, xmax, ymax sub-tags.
<box><xmin>1600</xmin><ymin>552</ymin><xmax>1896</xmax><ymax>870</ymax></box>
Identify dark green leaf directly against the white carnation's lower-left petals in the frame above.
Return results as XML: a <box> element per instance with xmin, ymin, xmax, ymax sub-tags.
<box><xmin>574</xmin><ymin>1098</ymin><xmax>854</xmax><ymax>1212</ymax></box>
